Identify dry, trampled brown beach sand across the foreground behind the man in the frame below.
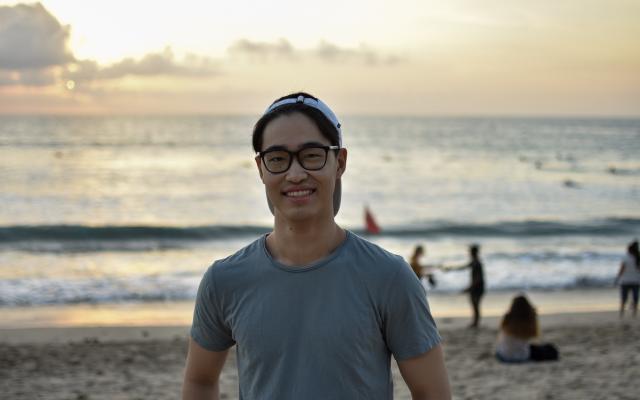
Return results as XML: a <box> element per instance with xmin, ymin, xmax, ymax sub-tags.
<box><xmin>0</xmin><ymin>312</ymin><xmax>640</xmax><ymax>399</ymax></box>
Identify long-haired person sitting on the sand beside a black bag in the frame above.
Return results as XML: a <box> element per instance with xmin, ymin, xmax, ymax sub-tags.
<box><xmin>496</xmin><ymin>295</ymin><xmax>558</xmax><ymax>363</ymax></box>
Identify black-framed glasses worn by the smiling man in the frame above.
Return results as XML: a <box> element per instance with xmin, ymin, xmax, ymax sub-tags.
<box><xmin>258</xmin><ymin>145</ymin><xmax>340</xmax><ymax>174</ymax></box>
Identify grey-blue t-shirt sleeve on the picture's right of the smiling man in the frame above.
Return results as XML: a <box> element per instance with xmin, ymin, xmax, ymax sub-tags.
<box><xmin>383</xmin><ymin>262</ymin><xmax>441</xmax><ymax>361</ymax></box>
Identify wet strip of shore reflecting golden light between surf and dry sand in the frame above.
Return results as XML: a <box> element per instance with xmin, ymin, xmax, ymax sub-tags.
<box><xmin>0</xmin><ymin>288</ymin><xmax>619</xmax><ymax>330</ymax></box>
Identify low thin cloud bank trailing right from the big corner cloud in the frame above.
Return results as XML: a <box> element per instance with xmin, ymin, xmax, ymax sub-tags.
<box><xmin>64</xmin><ymin>47</ymin><xmax>218</xmax><ymax>82</ymax></box>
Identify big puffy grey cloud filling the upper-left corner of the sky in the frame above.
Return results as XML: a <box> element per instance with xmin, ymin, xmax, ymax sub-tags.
<box><xmin>0</xmin><ymin>3</ymin><xmax>73</xmax><ymax>70</ymax></box>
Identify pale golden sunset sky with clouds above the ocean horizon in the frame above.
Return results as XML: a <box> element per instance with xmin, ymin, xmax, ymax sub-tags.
<box><xmin>0</xmin><ymin>0</ymin><xmax>640</xmax><ymax>117</ymax></box>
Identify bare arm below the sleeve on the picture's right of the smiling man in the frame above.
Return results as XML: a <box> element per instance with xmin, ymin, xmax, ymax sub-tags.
<box><xmin>398</xmin><ymin>345</ymin><xmax>451</xmax><ymax>400</ymax></box>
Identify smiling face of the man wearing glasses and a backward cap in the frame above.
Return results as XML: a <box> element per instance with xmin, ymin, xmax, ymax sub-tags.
<box><xmin>256</xmin><ymin>113</ymin><xmax>347</xmax><ymax>221</ymax></box>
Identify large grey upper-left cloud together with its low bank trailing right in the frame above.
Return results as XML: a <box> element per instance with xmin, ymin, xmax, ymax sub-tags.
<box><xmin>0</xmin><ymin>3</ymin><xmax>218</xmax><ymax>86</ymax></box>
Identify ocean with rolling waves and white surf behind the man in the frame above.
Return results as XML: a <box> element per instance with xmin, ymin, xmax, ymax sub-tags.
<box><xmin>0</xmin><ymin>116</ymin><xmax>640</xmax><ymax>312</ymax></box>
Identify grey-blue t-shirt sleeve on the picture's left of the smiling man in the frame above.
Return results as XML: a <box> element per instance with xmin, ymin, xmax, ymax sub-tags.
<box><xmin>191</xmin><ymin>264</ymin><xmax>235</xmax><ymax>351</ymax></box>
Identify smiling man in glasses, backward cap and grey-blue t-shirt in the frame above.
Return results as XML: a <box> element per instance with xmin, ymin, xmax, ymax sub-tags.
<box><xmin>183</xmin><ymin>93</ymin><xmax>451</xmax><ymax>400</ymax></box>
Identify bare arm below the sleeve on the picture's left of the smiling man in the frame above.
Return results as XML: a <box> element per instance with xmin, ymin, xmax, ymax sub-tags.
<box><xmin>182</xmin><ymin>339</ymin><xmax>229</xmax><ymax>400</ymax></box>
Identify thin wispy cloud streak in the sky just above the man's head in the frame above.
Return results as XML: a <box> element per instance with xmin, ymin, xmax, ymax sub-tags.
<box><xmin>228</xmin><ymin>39</ymin><xmax>400</xmax><ymax>66</ymax></box>
